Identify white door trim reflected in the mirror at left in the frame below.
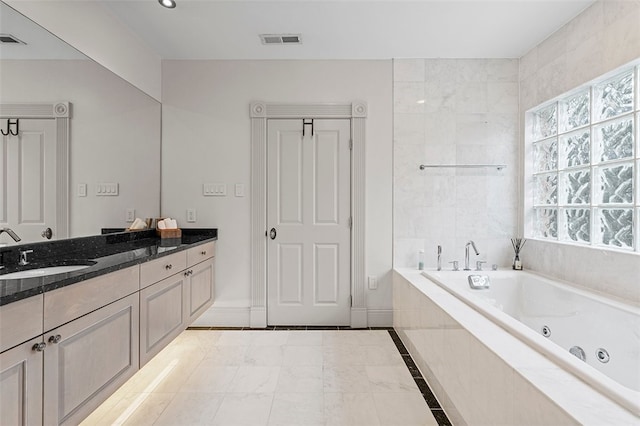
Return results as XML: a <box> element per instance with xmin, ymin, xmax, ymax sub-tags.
<box><xmin>0</xmin><ymin>102</ymin><xmax>71</xmax><ymax>239</ymax></box>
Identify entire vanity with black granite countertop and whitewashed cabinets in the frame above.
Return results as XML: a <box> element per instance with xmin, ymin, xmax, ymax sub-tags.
<box><xmin>0</xmin><ymin>229</ymin><xmax>217</xmax><ymax>425</ymax></box>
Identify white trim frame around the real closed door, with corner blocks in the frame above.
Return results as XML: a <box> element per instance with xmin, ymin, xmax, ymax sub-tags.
<box><xmin>249</xmin><ymin>101</ymin><xmax>367</xmax><ymax>328</ymax></box>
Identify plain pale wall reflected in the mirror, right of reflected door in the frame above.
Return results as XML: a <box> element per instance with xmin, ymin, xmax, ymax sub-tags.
<box><xmin>0</xmin><ymin>60</ymin><xmax>161</xmax><ymax>237</ymax></box>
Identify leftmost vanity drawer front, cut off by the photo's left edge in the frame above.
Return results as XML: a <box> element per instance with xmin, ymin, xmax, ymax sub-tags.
<box><xmin>0</xmin><ymin>294</ymin><xmax>42</xmax><ymax>352</ymax></box>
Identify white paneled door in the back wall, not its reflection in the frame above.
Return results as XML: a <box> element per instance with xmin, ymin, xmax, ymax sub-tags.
<box><xmin>267</xmin><ymin>119</ymin><xmax>351</xmax><ymax>325</ymax></box>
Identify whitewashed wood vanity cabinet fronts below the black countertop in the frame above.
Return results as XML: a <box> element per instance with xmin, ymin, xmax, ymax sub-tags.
<box><xmin>0</xmin><ymin>238</ymin><xmax>215</xmax><ymax>426</ymax></box>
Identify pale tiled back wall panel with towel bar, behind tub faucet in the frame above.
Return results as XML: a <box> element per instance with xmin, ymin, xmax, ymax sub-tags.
<box><xmin>393</xmin><ymin>59</ymin><xmax>519</xmax><ymax>267</ymax></box>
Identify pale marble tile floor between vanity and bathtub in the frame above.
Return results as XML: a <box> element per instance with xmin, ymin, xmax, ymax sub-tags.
<box><xmin>82</xmin><ymin>329</ymin><xmax>449</xmax><ymax>426</ymax></box>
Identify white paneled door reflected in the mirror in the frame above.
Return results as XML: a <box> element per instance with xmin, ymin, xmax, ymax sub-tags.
<box><xmin>0</xmin><ymin>119</ymin><xmax>56</xmax><ymax>243</ymax></box>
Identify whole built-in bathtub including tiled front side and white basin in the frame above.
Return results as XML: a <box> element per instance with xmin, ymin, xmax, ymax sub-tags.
<box><xmin>393</xmin><ymin>269</ymin><xmax>640</xmax><ymax>426</ymax></box>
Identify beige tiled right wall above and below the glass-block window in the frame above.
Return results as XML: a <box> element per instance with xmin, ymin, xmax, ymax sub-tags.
<box><xmin>520</xmin><ymin>0</ymin><xmax>640</xmax><ymax>303</ymax></box>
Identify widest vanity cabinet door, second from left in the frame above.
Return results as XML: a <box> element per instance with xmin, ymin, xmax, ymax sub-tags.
<box><xmin>43</xmin><ymin>293</ymin><xmax>139</xmax><ymax>425</ymax></box>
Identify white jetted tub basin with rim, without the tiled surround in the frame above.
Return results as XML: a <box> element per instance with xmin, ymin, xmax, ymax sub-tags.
<box><xmin>423</xmin><ymin>270</ymin><xmax>640</xmax><ymax>415</ymax></box>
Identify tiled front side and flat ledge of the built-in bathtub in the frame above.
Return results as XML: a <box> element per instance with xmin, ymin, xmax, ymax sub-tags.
<box><xmin>393</xmin><ymin>270</ymin><xmax>637</xmax><ymax>425</ymax></box>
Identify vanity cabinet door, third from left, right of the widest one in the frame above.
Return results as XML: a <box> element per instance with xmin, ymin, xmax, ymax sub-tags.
<box><xmin>140</xmin><ymin>271</ymin><xmax>187</xmax><ymax>366</ymax></box>
